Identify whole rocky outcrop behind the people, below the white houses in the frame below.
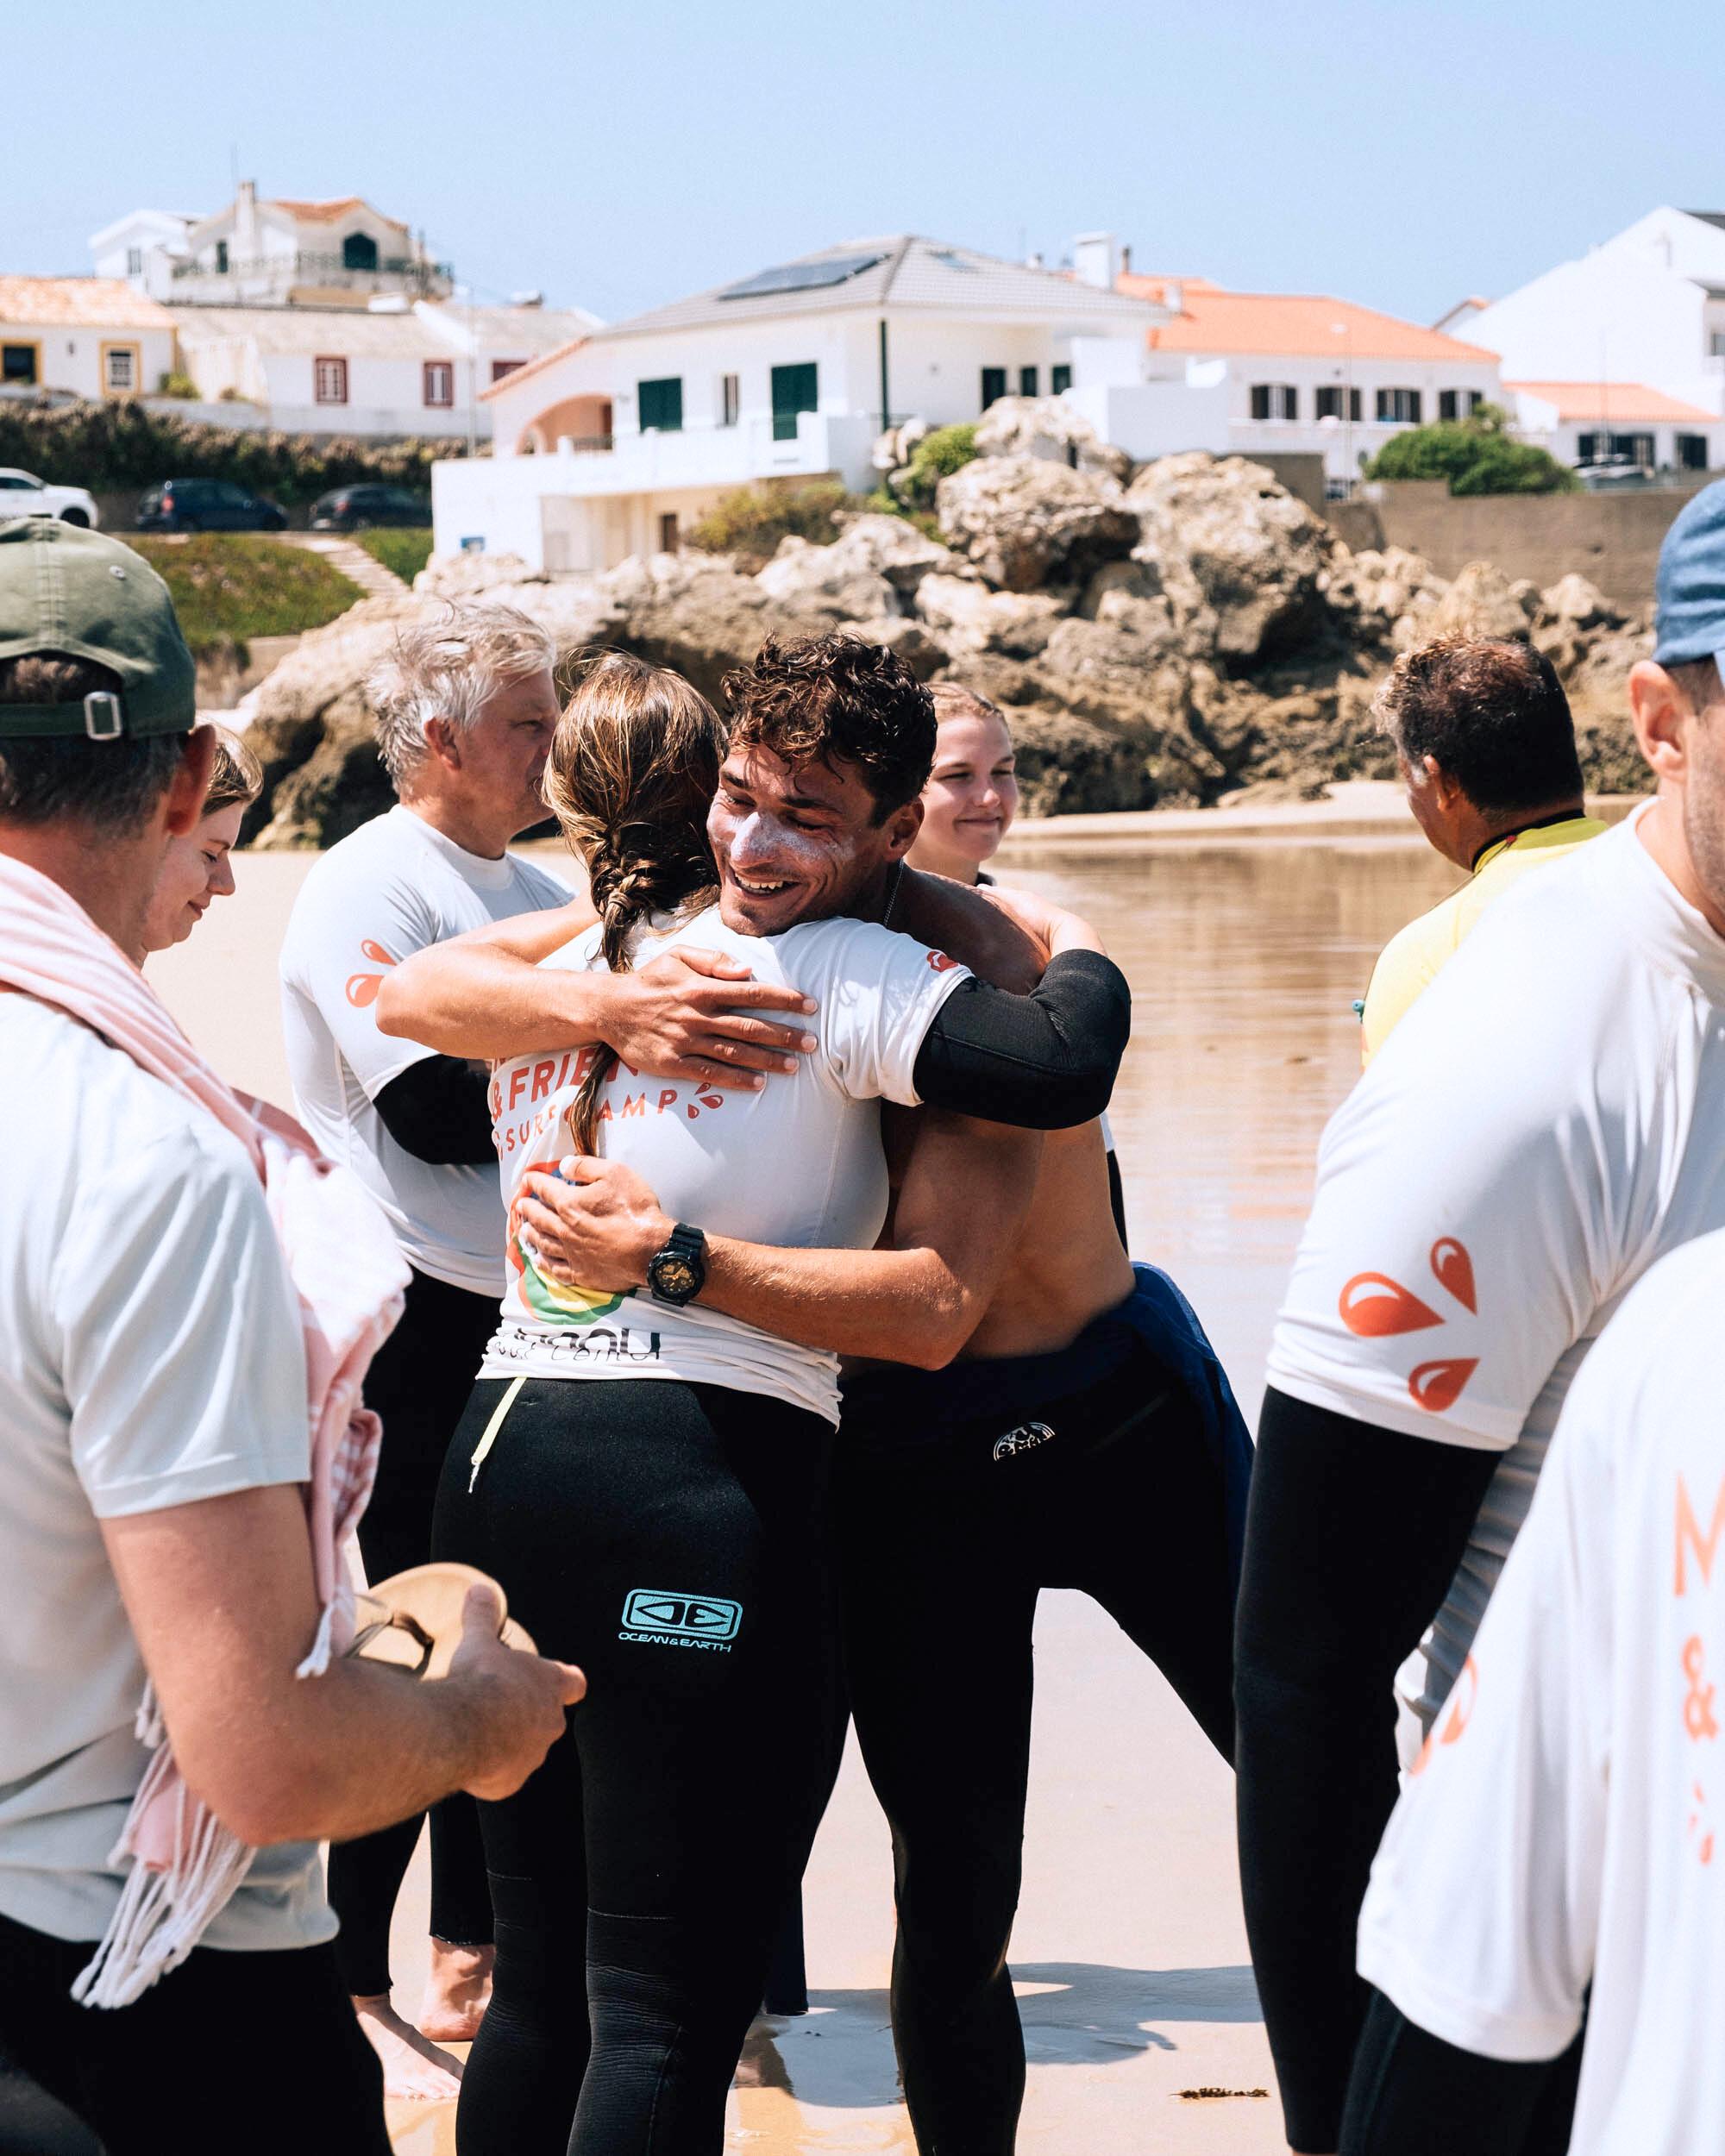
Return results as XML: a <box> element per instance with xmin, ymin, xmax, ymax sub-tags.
<box><xmin>240</xmin><ymin>448</ymin><xmax>1652</xmax><ymax>845</ymax></box>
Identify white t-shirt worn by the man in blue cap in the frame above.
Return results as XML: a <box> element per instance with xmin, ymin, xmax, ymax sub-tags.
<box><xmin>1268</xmin><ymin>815</ymin><xmax>1725</xmax><ymax>1714</ymax></box>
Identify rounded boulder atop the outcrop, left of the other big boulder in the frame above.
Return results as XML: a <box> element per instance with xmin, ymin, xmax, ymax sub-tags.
<box><xmin>936</xmin><ymin>457</ymin><xmax>1138</xmax><ymax>591</ymax></box>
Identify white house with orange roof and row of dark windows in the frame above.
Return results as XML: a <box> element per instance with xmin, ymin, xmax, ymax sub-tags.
<box><xmin>1091</xmin><ymin>259</ymin><xmax>1501</xmax><ymax>492</ymax></box>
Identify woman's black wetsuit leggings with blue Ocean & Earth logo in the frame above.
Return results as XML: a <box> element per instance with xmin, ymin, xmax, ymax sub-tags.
<box><xmin>436</xmin><ymin>1378</ymin><xmax>839</xmax><ymax>2156</ymax></box>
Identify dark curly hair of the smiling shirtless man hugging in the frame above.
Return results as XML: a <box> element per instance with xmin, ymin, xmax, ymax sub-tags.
<box><xmin>724</xmin><ymin>636</ymin><xmax>936</xmax><ymax>824</ymax></box>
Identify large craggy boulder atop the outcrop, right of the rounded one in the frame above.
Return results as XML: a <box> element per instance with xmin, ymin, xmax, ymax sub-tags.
<box><xmin>1126</xmin><ymin>451</ymin><xmax>1335</xmax><ymax>671</ymax></box>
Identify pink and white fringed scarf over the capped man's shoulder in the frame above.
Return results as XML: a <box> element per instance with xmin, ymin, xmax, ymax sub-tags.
<box><xmin>0</xmin><ymin>856</ymin><xmax>408</xmax><ymax>2008</ymax></box>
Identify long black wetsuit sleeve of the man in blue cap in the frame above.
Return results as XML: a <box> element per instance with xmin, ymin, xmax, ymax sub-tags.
<box><xmin>1236</xmin><ymin>1391</ymin><xmax>1499</xmax><ymax>2156</ymax></box>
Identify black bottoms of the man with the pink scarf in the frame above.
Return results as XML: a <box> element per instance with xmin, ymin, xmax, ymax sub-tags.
<box><xmin>0</xmin><ymin>1917</ymin><xmax>391</xmax><ymax>2156</ymax></box>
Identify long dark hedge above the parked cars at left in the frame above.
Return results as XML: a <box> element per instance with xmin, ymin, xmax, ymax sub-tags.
<box><xmin>0</xmin><ymin>397</ymin><xmax>474</xmax><ymax>503</ymax></box>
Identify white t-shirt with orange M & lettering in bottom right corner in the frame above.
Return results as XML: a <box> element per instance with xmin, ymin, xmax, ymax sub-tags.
<box><xmin>1358</xmin><ymin>1233</ymin><xmax>1725</xmax><ymax>2156</ymax></box>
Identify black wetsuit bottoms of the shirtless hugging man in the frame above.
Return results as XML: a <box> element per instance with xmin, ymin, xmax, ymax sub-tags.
<box><xmin>837</xmin><ymin>1344</ymin><xmax>1233</xmax><ymax>2156</ymax></box>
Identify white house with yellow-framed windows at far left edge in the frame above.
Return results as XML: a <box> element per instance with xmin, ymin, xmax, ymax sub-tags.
<box><xmin>0</xmin><ymin>276</ymin><xmax>175</xmax><ymax>397</ymax></box>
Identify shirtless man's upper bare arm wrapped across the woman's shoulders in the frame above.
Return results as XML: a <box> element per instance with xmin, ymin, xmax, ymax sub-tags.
<box><xmin>375</xmin><ymin>901</ymin><xmax>815</xmax><ymax>1091</ymax></box>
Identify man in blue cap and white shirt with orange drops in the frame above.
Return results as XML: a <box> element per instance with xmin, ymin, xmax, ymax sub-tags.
<box><xmin>1236</xmin><ymin>486</ymin><xmax>1725</xmax><ymax>2156</ymax></box>
